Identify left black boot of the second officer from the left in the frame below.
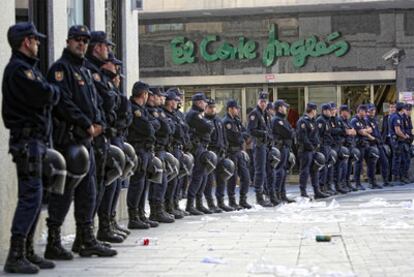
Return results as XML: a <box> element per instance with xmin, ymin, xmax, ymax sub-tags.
<box><xmin>44</xmin><ymin>227</ymin><xmax>73</xmax><ymax>261</ymax></box>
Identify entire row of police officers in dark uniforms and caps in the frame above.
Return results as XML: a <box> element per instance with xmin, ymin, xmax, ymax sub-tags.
<box><xmin>2</xmin><ymin>22</ymin><xmax>413</xmax><ymax>273</ymax></box>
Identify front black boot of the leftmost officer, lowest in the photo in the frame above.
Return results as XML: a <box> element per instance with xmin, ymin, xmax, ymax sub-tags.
<box><xmin>4</xmin><ymin>237</ymin><xmax>39</xmax><ymax>274</ymax></box>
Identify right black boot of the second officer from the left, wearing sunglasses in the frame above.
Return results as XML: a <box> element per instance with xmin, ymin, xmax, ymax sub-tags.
<box><xmin>79</xmin><ymin>226</ymin><xmax>118</xmax><ymax>257</ymax></box>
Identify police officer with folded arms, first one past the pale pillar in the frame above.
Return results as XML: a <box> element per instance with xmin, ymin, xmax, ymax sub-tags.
<box><xmin>127</xmin><ymin>82</ymin><xmax>160</xmax><ymax>229</ymax></box>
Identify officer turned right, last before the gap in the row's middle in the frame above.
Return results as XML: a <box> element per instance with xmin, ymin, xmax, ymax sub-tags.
<box><xmin>272</xmin><ymin>99</ymin><xmax>295</xmax><ymax>203</ymax></box>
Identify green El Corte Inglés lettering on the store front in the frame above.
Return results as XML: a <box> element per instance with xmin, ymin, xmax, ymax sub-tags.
<box><xmin>170</xmin><ymin>25</ymin><xmax>350</xmax><ymax>68</ymax></box>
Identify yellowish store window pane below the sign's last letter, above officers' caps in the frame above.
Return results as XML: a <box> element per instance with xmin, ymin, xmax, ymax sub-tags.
<box><xmin>341</xmin><ymin>85</ymin><xmax>371</xmax><ymax>111</ymax></box>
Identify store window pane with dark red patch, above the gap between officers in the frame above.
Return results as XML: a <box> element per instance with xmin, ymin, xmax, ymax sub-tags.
<box><xmin>277</xmin><ymin>87</ymin><xmax>305</xmax><ymax>128</ymax></box>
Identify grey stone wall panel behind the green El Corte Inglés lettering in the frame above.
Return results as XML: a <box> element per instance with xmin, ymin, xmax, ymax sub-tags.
<box><xmin>140</xmin><ymin>10</ymin><xmax>414</xmax><ymax>78</ymax></box>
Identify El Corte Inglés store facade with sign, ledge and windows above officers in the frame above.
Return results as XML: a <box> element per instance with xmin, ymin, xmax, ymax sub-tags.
<box><xmin>139</xmin><ymin>9</ymin><xmax>414</xmax><ymax>122</ymax></box>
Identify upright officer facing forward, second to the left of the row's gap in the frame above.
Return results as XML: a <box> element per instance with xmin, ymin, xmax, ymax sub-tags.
<box><xmin>247</xmin><ymin>91</ymin><xmax>273</xmax><ymax>207</ymax></box>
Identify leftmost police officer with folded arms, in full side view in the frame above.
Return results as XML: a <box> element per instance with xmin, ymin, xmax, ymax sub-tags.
<box><xmin>2</xmin><ymin>22</ymin><xmax>60</xmax><ymax>273</ymax></box>
